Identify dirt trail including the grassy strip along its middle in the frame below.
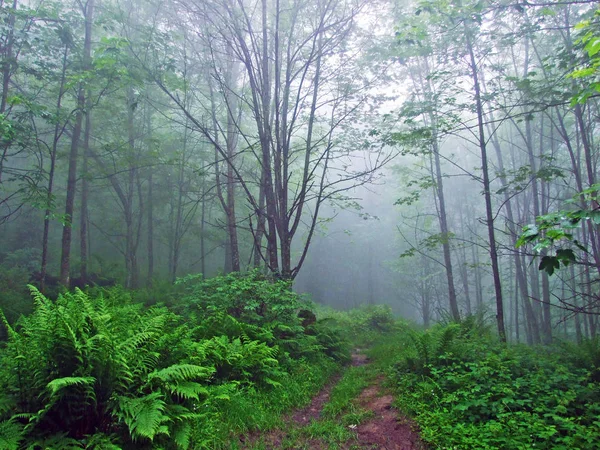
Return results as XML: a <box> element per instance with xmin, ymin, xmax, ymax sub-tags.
<box><xmin>240</xmin><ymin>349</ymin><xmax>426</xmax><ymax>450</ymax></box>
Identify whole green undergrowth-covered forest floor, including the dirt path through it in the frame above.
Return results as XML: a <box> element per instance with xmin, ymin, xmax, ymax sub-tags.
<box><xmin>0</xmin><ymin>272</ymin><xmax>600</xmax><ymax>450</ymax></box>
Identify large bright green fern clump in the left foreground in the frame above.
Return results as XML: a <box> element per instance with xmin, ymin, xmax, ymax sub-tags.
<box><xmin>0</xmin><ymin>287</ymin><xmax>214</xmax><ymax>448</ymax></box>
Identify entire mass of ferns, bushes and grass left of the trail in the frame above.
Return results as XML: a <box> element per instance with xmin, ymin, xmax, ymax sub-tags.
<box><xmin>0</xmin><ymin>274</ymin><xmax>348</xmax><ymax>449</ymax></box>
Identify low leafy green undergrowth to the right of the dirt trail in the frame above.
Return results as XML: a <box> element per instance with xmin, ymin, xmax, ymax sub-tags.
<box><xmin>390</xmin><ymin>319</ymin><xmax>600</xmax><ymax>449</ymax></box>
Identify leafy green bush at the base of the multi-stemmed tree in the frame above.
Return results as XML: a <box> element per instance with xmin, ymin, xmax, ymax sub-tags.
<box><xmin>177</xmin><ymin>271</ymin><xmax>349</xmax><ymax>364</ymax></box>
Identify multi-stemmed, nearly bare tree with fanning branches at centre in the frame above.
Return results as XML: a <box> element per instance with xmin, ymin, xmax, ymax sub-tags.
<box><xmin>138</xmin><ymin>0</ymin><xmax>393</xmax><ymax>279</ymax></box>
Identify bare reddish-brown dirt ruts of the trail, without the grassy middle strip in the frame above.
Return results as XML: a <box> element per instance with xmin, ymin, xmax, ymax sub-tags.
<box><xmin>240</xmin><ymin>350</ymin><xmax>426</xmax><ymax>450</ymax></box>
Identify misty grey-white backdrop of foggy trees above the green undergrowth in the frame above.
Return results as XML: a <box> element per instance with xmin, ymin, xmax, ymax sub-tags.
<box><xmin>0</xmin><ymin>0</ymin><xmax>600</xmax><ymax>343</ymax></box>
